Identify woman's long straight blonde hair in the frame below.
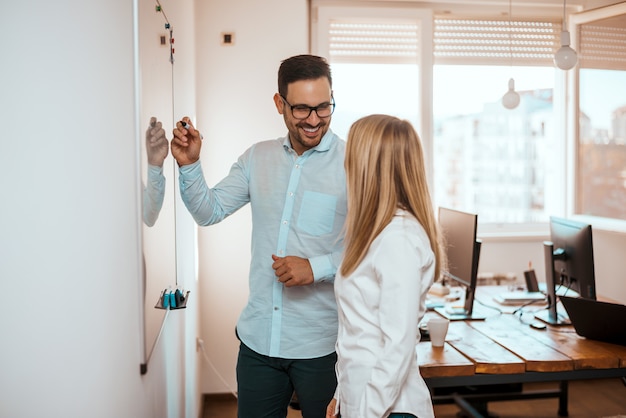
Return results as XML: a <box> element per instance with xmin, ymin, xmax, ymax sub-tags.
<box><xmin>341</xmin><ymin>115</ymin><xmax>445</xmax><ymax>279</ymax></box>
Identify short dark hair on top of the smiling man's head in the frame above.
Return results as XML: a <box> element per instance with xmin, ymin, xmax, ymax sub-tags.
<box><xmin>278</xmin><ymin>55</ymin><xmax>333</xmax><ymax>97</ymax></box>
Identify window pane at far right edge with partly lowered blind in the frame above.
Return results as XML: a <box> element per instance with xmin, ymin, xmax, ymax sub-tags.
<box><xmin>574</xmin><ymin>10</ymin><xmax>626</xmax><ymax>220</ymax></box>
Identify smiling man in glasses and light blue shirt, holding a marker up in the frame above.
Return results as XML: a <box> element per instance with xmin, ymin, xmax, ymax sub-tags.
<box><xmin>171</xmin><ymin>55</ymin><xmax>346</xmax><ymax>418</ymax></box>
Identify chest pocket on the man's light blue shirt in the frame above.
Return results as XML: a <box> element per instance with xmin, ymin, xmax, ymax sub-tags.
<box><xmin>298</xmin><ymin>191</ymin><xmax>337</xmax><ymax>236</ymax></box>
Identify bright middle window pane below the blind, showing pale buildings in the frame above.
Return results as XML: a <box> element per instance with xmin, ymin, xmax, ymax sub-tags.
<box><xmin>433</xmin><ymin>65</ymin><xmax>562</xmax><ymax>223</ymax></box>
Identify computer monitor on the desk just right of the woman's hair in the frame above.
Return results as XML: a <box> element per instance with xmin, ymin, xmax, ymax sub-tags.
<box><xmin>435</xmin><ymin>207</ymin><xmax>485</xmax><ymax>320</ymax></box>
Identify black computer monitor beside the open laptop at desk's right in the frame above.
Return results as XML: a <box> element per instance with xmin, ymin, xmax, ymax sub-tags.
<box><xmin>535</xmin><ymin>216</ymin><xmax>596</xmax><ymax>325</ymax></box>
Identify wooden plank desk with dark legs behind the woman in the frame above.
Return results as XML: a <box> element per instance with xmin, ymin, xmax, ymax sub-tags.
<box><xmin>417</xmin><ymin>286</ymin><xmax>626</xmax><ymax>417</ymax></box>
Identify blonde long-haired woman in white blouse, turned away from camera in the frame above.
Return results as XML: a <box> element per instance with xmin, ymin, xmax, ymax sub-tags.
<box><xmin>326</xmin><ymin>115</ymin><xmax>444</xmax><ymax>418</ymax></box>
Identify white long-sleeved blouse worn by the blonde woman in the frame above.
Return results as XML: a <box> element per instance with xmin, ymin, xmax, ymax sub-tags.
<box><xmin>335</xmin><ymin>210</ymin><xmax>435</xmax><ymax>418</ymax></box>
